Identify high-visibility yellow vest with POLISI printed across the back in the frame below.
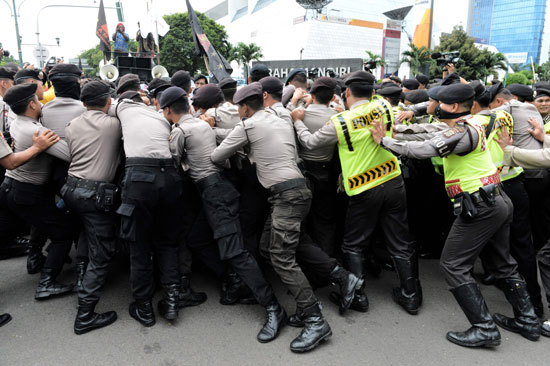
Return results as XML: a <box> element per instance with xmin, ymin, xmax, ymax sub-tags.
<box><xmin>331</xmin><ymin>96</ymin><xmax>401</xmax><ymax>196</ymax></box>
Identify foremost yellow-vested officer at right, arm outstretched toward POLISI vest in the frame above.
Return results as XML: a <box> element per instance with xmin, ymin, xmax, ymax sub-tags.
<box><xmin>372</xmin><ymin>84</ymin><xmax>540</xmax><ymax>347</ymax></box>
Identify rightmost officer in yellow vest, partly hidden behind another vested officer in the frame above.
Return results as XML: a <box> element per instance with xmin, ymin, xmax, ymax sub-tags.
<box><xmin>470</xmin><ymin>80</ymin><xmax>544</xmax><ymax>316</ymax></box>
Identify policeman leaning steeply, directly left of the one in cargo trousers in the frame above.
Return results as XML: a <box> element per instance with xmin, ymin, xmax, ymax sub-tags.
<box><xmin>161</xmin><ymin>84</ymin><xmax>286</xmax><ymax>343</ymax></box>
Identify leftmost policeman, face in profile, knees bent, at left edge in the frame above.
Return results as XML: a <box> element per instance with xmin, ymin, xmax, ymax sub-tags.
<box><xmin>3</xmin><ymin>84</ymin><xmax>74</xmax><ymax>299</ymax></box>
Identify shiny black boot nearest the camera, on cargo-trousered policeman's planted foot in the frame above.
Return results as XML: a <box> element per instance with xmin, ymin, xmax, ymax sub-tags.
<box><xmin>290</xmin><ymin>303</ymin><xmax>332</xmax><ymax>353</ymax></box>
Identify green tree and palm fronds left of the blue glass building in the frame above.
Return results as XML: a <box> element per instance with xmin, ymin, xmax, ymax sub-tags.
<box><xmin>436</xmin><ymin>26</ymin><xmax>506</xmax><ymax>80</ymax></box>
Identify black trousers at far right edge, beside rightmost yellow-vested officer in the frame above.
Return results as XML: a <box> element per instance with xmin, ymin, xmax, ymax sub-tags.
<box><xmin>524</xmin><ymin>171</ymin><xmax>550</xmax><ymax>250</ymax></box>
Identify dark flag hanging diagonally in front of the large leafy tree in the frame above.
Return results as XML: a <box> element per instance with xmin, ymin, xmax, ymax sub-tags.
<box><xmin>186</xmin><ymin>0</ymin><xmax>233</xmax><ymax>82</ymax></box>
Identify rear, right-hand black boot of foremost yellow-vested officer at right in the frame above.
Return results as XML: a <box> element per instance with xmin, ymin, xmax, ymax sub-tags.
<box><xmin>493</xmin><ymin>280</ymin><xmax>540</xmax><ymax>341</ymax></box>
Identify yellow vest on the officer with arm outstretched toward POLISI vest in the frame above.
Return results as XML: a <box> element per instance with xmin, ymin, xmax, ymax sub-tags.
<box><xmin>443</xmin><ymin>122</ymin><xmax>500</xmax><ymax>198</ymax></box>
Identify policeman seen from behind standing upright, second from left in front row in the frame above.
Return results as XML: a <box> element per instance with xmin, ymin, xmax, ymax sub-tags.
<box><xmin>62</xmin><ymin>81</ymin><xmax>122</xmax><ymax>334</ymax></box>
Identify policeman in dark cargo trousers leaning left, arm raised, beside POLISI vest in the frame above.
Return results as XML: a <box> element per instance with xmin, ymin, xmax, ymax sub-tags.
<box><xmin>211</xmin><ymin>83</ymin><xmax>332</xmax><ymax>352</ymax></box>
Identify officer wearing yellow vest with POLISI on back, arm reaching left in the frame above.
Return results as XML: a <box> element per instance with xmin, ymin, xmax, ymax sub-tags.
<box><xmin>293</xmin><ymin>71</ymin><xmax>422</xmax><ymax>314</ymax></box>
